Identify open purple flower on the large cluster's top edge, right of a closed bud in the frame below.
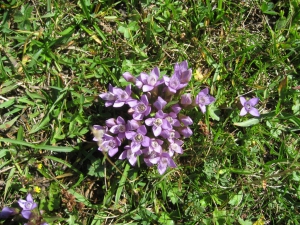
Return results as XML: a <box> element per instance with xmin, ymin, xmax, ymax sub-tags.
<box><xmin>136</xmin><ymin>67</ymin><xmax>163</xmax><ymax>92</ymax></box>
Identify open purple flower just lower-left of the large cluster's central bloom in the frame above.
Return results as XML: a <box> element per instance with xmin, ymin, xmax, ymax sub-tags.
<box><xmin>125</xmin><ymin>125</ymin><xmax>150</xmax><ymax>153</ymax></box>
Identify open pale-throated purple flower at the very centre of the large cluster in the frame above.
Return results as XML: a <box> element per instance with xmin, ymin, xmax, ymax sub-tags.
<box><xmin>145</xmin><ymin>110</ymin><xmax>172</xmax><ymax>137</ymax></box>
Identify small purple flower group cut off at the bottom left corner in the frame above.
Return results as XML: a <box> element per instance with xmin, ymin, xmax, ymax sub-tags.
<box><xmin>0</xmin><ymin>194</ymin><xmax>48</xmax><ymax>225</ymax></box>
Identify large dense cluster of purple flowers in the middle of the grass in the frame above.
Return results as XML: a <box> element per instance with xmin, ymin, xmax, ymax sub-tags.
<box><xmin>93</xmin><ymin>61</ymin><xmax>215</xmax><ymax>174</ymax></box>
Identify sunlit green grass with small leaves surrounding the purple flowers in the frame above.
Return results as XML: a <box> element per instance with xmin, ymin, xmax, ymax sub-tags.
<box><xmin>0</xmin><ymin>0</ymin><xmax>300</xmax><ymax>225</ymax></box>
